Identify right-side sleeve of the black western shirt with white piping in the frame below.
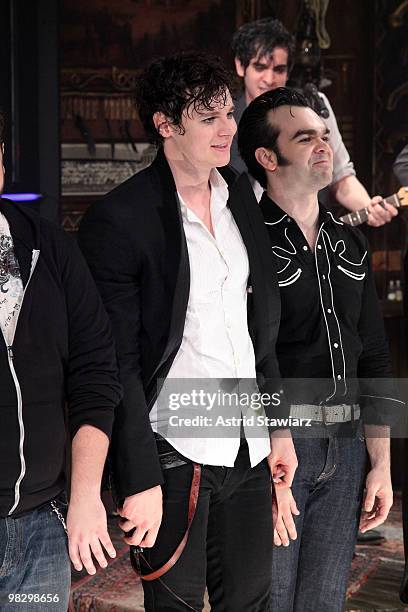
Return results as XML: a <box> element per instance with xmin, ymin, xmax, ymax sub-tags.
<box><xmin>357</xmin><ymin>239</ymin><xmax>405</xmax><ymax>426</ymax></box>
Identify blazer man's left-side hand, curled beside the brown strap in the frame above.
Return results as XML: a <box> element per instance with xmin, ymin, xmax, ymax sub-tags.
<box><xmin>118</xmin><ymin>485</ymin><xmax>163</xmax><ymax>548</ymax></box>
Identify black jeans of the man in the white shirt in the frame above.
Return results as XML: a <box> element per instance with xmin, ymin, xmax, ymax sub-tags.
<box><xmin>143</xmin><ymin>442</ymin><xmax>273</xmax><ymax>612</ymax></box>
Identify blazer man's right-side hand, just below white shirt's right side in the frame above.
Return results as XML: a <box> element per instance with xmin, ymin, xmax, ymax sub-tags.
<box><xmin>268</xmin><ymin>429</ymin><xmax>298</xmax><ymax>489</ymax></box>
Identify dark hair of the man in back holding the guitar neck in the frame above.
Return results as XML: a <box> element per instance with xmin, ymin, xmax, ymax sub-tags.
<box><xmin>232</xmin><ymin>17</ymin><xmax>295</xmax><ymax>72</ymax></box>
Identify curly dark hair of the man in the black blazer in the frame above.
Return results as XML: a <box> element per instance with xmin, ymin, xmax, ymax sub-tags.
<box><xmin>135</xmin><ymin>52</ymin><xmax>233</xmax><ymax>143</ymax></box>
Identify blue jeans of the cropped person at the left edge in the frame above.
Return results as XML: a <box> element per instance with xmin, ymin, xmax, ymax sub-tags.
<box><xmin>0</xmin><ymin>502</ymin><xmax>71</xmax><ymax>612</ymax></box>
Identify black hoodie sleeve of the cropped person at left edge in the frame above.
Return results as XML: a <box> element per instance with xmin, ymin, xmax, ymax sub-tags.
<box><xmin>61</xmin><ymin>234</ymin><xmax>122</xmax><ymax>438</ymax></box>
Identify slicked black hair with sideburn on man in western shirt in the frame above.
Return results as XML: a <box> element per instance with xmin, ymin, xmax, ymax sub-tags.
<box><xmin>238</xmin><ymin>87</ymin><xmax>310</xmax><ymax>189</ymax></box>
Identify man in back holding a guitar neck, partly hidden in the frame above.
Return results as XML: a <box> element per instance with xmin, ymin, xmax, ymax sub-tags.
<box><xmin>231</xmin><ymin>17</ymin><xmax>397</xmax><ymax>226</ymax></box>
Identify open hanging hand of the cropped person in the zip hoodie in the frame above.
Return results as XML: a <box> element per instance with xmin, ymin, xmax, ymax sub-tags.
<box><xmin>67</xmin><ymin>497</ymin><xmax>116</xmax><ymax>574</ymax></box>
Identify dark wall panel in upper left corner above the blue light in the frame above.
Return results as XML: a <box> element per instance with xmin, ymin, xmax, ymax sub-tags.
<box><xmin>0</xmin><ymin>0</ymin><xmax>60</xmax><ymax>221</ymax></box>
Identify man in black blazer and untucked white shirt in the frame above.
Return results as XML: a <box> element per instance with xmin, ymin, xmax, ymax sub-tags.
<box><xmin>80</xmin><ymin>53</ymin><xmax>296</xmax><ymax>612</ymax></box>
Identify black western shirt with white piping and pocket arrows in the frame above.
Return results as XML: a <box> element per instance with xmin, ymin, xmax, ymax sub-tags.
<box><xmin>260</xmin><ymin>193</ymin><xmax>402</xmax><ymax>424</ymax></box>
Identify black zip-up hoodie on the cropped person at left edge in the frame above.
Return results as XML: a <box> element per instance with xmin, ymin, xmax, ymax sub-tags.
<box><xmin>0</xmin><ymin>199</ymin><xmax>121</xmax><ymax>517</ymax></box>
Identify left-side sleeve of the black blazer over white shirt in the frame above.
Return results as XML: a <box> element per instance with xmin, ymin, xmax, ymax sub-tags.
<box><xmin>79</xmin><ymin>197</ymin><xmax>163</xmax><ymax>499</ymax></box>
